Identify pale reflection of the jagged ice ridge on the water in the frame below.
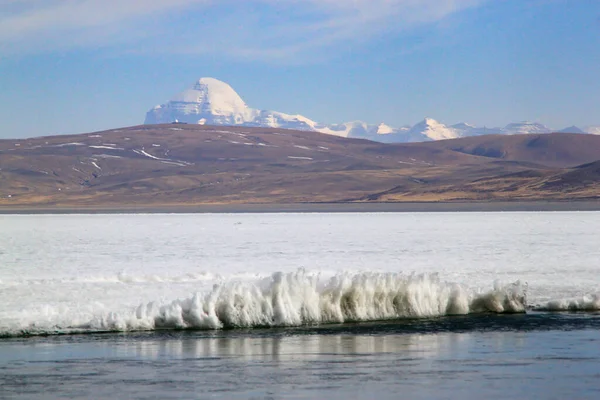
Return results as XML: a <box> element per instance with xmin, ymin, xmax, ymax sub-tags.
<box><xmin>124</xmin><ymin>333</ymin><xmax>468</xmax><ymax>362</ymax></box>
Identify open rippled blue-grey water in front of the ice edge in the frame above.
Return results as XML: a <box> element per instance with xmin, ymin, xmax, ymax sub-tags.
<box><xmin>0</xmin><ymin>325</ymin><xmax>600</xmax><ymax>400</ymax></box>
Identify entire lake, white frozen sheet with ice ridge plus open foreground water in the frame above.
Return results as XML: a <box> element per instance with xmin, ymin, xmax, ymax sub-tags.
<box><xmin>0</xmin><ymin>212</ymin><xmax>600</xmax><ymax>399</ymax></box>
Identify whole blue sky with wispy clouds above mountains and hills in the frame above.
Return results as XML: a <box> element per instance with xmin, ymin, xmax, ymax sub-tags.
<box><xmin>0</xmin><ymin>0</ymin><xmax>600</xmax><ymax>138</ymax></box>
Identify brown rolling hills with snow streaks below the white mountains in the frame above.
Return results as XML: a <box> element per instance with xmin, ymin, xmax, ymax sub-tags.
<box><xmin>0</xmin><ymin>124</ymin><xmax>600</xmax><ymax>207</ymax></box>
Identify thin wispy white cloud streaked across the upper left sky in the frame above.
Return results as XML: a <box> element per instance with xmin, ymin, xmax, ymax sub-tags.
<box><xmin>0</xmin><ymin>0</ymin><xmax>486</xmax><ymax>60</ymax></box>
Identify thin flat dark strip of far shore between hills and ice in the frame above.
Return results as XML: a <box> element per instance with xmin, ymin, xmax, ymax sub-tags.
<box><xmin>0</xmin><ymin>201</ymin><xmax>600</xmax><ymax>215</ymax></box>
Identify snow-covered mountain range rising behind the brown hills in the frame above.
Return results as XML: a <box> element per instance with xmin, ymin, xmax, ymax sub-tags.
<box><xmin>144</xmin><ymin>78</ymin><xmax>600</xmax><ymax>143</ymax></box>
